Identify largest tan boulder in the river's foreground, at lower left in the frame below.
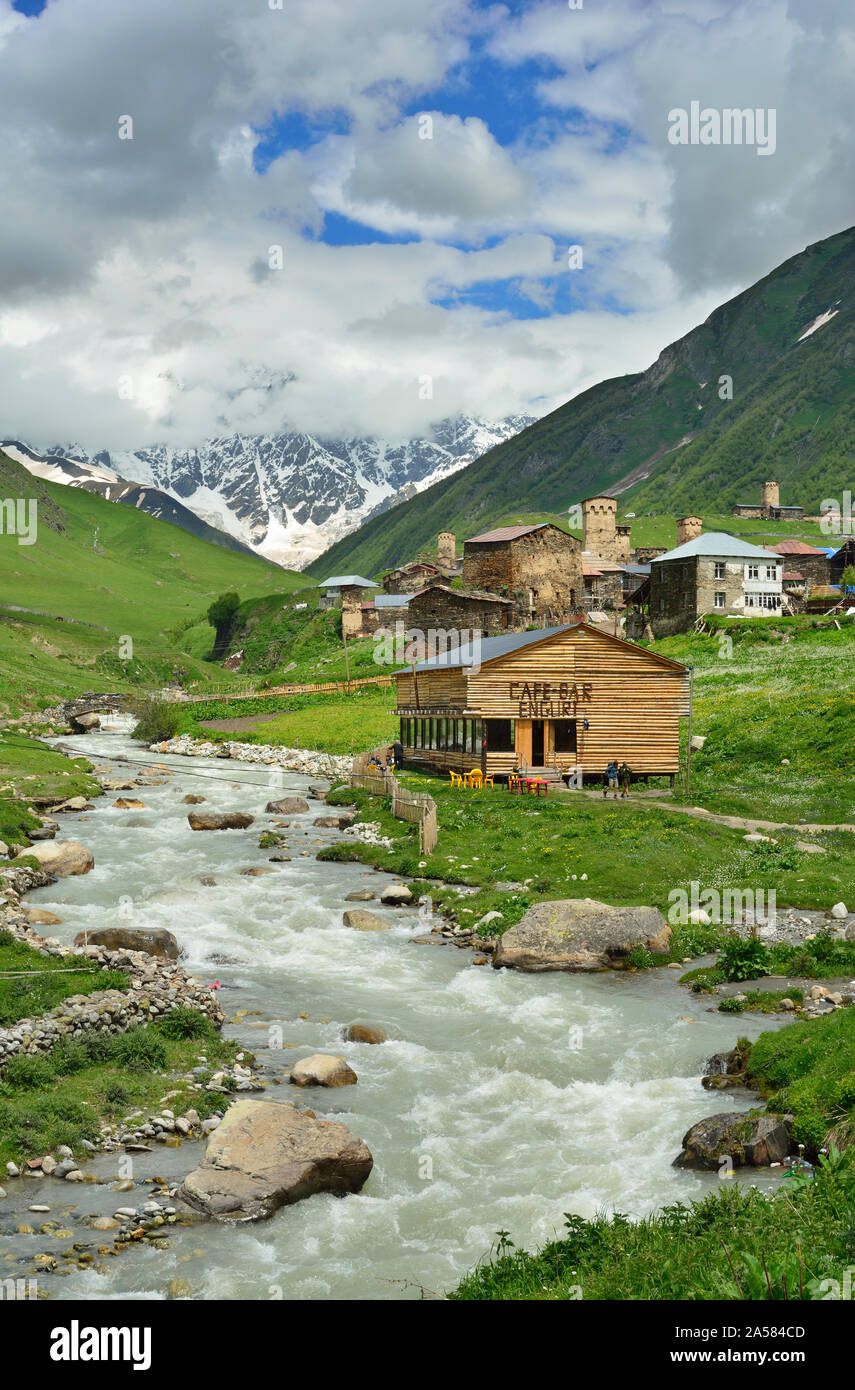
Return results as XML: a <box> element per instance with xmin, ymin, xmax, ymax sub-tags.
<box><xmin>178</xmin><ymin>1101</ymin><xmax>374</xmax><ymax>1220</ymax></box>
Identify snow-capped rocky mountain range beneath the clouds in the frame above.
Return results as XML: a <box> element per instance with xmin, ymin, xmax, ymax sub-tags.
<box><xmin>18</xmin><ymin>416</ymin><xmax>532</xmax><ymax>570</ymax></box>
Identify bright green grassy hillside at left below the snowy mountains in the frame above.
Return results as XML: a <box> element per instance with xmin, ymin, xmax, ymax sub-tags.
<box><xmin>0</xmin><ymin>453</ymin><xmax>306</xmax><ymax>713</ymax></box>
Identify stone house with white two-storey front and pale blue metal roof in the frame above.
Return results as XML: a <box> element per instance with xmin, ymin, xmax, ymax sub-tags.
<box><xmin>640</xmin><ymin>531</ymin><xmax>784</xmax><ymax>637</ymax></box>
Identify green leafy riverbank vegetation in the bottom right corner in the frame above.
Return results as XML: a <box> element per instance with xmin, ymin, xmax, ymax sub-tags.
<box><xmin>449</xmin><ymin>1145</ymin><xmax>855</xmax><ymax>1302</ymax></box>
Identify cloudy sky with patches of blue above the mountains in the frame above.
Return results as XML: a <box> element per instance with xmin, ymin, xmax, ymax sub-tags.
<box><xmin>0</xmin><ymin>0</ymin><xmax>855</xmax><ymax>450</ymax></box>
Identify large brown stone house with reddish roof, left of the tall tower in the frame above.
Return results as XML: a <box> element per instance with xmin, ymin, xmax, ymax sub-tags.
<box><xmin>463</xmin><ymin>521</ymin><xmax>584</xmax><ymax>623</ymax></box>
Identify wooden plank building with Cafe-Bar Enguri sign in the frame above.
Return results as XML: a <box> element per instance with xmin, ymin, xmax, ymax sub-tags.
<box><xmin>396</xmin><ymin>620</ymin><xmax>690</xmax><ymax>784</ymax></box>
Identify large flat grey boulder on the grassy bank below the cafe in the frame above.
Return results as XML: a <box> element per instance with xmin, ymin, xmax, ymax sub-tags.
<box><xmin>492</xmin><ymin>898</ymin><xmax>671</xmax><ymax>970</ymax></box>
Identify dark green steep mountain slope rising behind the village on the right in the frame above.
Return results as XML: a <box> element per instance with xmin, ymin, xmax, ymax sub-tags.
<box><xmin>309</xmin><ymin>228</ymin><xmax>855</xmax><ymax>577</ymax></box>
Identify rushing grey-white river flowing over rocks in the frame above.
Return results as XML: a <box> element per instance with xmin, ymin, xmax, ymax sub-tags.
<box><xmin>0</xmin><ymin>733</ymin><xmax>774</xmax><ymax>1300</ymax></box>
